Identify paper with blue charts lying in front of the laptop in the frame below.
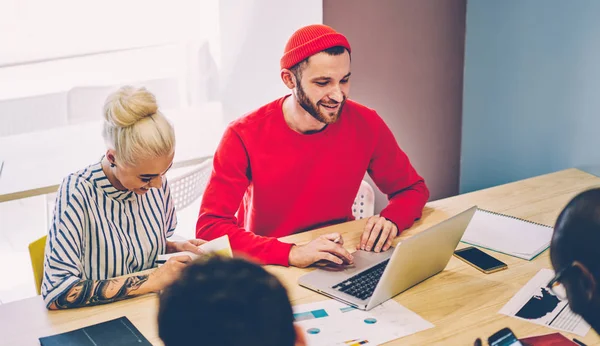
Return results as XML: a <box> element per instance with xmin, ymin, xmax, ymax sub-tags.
<box><xmin>294</xmin><ymin>300</ymin><xmax>433</xmax><ymax>346</ymax></box>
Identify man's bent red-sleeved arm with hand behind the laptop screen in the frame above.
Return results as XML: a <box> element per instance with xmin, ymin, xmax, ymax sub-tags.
<box><xmin>357</xmin><ymin>118</ymin><xmax>429</xmax><ymax>252</ymax></box>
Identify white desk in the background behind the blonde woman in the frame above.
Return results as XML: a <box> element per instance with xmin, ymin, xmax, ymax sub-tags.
<box><xmin>0</xmin><ymin>105</ymin><xmax>225</xmax><ymax>202</ymax></box>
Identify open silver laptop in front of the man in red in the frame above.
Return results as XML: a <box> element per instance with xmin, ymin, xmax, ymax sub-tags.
<box><xmin>298</xmin><ymin>207</ymin><xmax>477</xmax><ymax>310</ymax></box>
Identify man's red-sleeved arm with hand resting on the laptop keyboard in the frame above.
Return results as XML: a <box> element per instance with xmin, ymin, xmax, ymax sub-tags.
<box><xmin>196</xmin><ymin>126</ymin><xmax>351</xmax><ymax>266</ymax></box>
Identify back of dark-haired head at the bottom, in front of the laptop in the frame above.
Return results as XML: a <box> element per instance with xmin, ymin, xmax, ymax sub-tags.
<box><xmin>158</xmin><ymin>256</ymin><xmax>296</xmax><ymax>346</ymax></box>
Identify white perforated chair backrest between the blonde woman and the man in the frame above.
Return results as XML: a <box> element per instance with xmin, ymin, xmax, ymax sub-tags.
<box><xmin>169</xmin><ymin>158</ymin><xmax>212</xmax><ymax>210</ymax></box>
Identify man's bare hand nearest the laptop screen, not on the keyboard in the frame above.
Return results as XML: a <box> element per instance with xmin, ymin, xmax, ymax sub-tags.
<box><xmin>356</xmin><ymin>215</ymin><xmax>398</xmax><ymax>252</ymax></box>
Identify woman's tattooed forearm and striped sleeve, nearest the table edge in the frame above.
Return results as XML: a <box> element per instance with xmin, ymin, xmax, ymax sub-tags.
<box><xmin>42</xmin><ymin>176</ymin><xmax>191</xmax><ymax>309</ymax></box>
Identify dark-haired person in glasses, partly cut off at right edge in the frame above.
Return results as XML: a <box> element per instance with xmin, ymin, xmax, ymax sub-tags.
<box><xmin>548</xmin><ymin>188</ymin><xmax>600</xmax><ymax>333</ymax></box>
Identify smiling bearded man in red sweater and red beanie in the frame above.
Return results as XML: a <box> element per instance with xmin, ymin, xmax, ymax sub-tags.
<box><xmin>196</xmin><ymin>25</ymin><xmax>429</xmax><ymax>267</ymax></box>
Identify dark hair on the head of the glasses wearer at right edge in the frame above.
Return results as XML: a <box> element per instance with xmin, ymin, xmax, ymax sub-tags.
<box><xmin>550</xmin><ymin>188</ymin><xmax>600</xmax><ymax>277</ymax></box>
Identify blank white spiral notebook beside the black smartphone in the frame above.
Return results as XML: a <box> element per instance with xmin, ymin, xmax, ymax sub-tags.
<box><xmin>461</xmin><ymin>209</ymin><xmax>553</xmax><ymax>260</ymax></box>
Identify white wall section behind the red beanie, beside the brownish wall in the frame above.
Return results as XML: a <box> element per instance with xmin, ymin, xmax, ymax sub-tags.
<box><xmin>219</xmin><ymin>0</ymin><xmax>323</xmax><ymax>121</ymax></box>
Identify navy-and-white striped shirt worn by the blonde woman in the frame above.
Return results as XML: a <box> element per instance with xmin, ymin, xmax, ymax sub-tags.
<box><xmin>42</xmin><ymin>163</ymin><xmax>177</xmax><ymax>305</ymax></box>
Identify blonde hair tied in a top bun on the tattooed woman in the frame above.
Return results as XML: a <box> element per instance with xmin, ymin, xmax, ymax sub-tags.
<box><xmin>103</xmin><ymin>86</ymin><xmax>175</xmax><ymax>164</ymax></box>
